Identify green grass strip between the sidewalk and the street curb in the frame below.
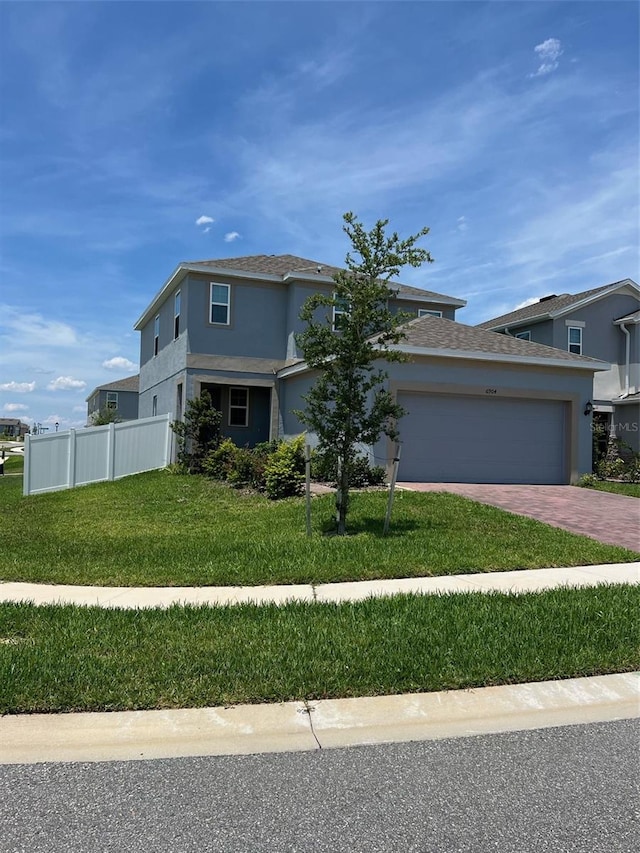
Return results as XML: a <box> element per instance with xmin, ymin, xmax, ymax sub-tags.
<box><xmin>0</xmin><ymin>586</ymin><xmax>640</xmax><ymax>713</ymax></box>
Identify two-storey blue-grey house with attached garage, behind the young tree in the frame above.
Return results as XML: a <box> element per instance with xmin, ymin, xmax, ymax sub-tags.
<box><xmin>135</xmin><ymin>255</ymin><xmax>608</xmax><ymax>483</ymax></box>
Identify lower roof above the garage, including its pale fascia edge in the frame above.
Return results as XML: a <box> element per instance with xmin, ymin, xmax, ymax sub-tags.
<box><xmin>278</xmin><ymin>316</ymin><xmax>610</xmax><ymax>376</ymax></box>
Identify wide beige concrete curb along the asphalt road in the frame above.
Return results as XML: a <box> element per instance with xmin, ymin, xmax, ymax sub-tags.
<box><xmin>0</xmin><ymin>672</ymin><xmax>640</xmax><ymax>764</ymax></box>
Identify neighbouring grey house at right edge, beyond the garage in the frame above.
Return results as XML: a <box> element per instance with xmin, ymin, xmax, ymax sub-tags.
<box><xmin>478</xmin><ymin>279</ymin><xmax>640</xmax><ymax>451</ymax></box>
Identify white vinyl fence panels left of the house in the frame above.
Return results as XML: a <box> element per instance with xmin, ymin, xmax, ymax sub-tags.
<box><xmin>23</xmin><ymin>415</ymin><xmax>172</xmax><ymax>495</ymax></box>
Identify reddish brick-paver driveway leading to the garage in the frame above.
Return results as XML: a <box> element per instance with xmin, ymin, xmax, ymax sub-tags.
<box><xmin>398</xmin><ymin>483</ymin><xmax>640</xmax><ymax>551</ymax></box>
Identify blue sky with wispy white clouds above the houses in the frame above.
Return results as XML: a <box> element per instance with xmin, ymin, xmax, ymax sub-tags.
<box><xmin>0</xmin><ymin>0</ymin><xmax>639</xmax><ymax>428</ymax></box>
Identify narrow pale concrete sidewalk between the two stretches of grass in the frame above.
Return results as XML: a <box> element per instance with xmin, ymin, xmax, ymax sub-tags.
<box><xmin>0</xmin><ymin>563</ymin><xmax>640</xmax><ymax>610</ymax></box>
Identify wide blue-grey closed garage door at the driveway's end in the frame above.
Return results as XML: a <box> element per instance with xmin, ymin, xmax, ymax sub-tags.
<box><xmin>398</xmin><ymin>393</ymin><xmax>568</xmax><ymax>484</ymax></box>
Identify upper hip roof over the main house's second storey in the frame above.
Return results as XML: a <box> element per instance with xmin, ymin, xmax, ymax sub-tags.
<box><xmin>134</xmin><ymin>255</ymin><xmax>467</xmax><ymax>329</ymax></box>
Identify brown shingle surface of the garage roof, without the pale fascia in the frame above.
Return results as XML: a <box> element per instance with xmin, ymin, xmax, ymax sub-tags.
<box><xmin>401</xmin><ymin>316</ymin><xmax>602</xmax><ymax>365</ymax></box>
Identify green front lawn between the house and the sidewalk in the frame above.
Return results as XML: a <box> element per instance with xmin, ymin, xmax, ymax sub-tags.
<box><xmin>0</xmin><ymin>471</ymin><xmax>638</xmax><ymax>586</ymax></box>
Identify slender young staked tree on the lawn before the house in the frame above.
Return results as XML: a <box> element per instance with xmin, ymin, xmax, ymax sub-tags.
<box><xmin>297</xmin><ymin>213</ymin><xmax>432</xmax><ymax>534</ymax></box>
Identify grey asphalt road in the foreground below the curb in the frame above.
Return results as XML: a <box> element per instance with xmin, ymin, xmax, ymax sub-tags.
<box><xmin>0</xmin><ymin>721</ymin><xmax>640</xmax><ymax>853</ymax></box>
